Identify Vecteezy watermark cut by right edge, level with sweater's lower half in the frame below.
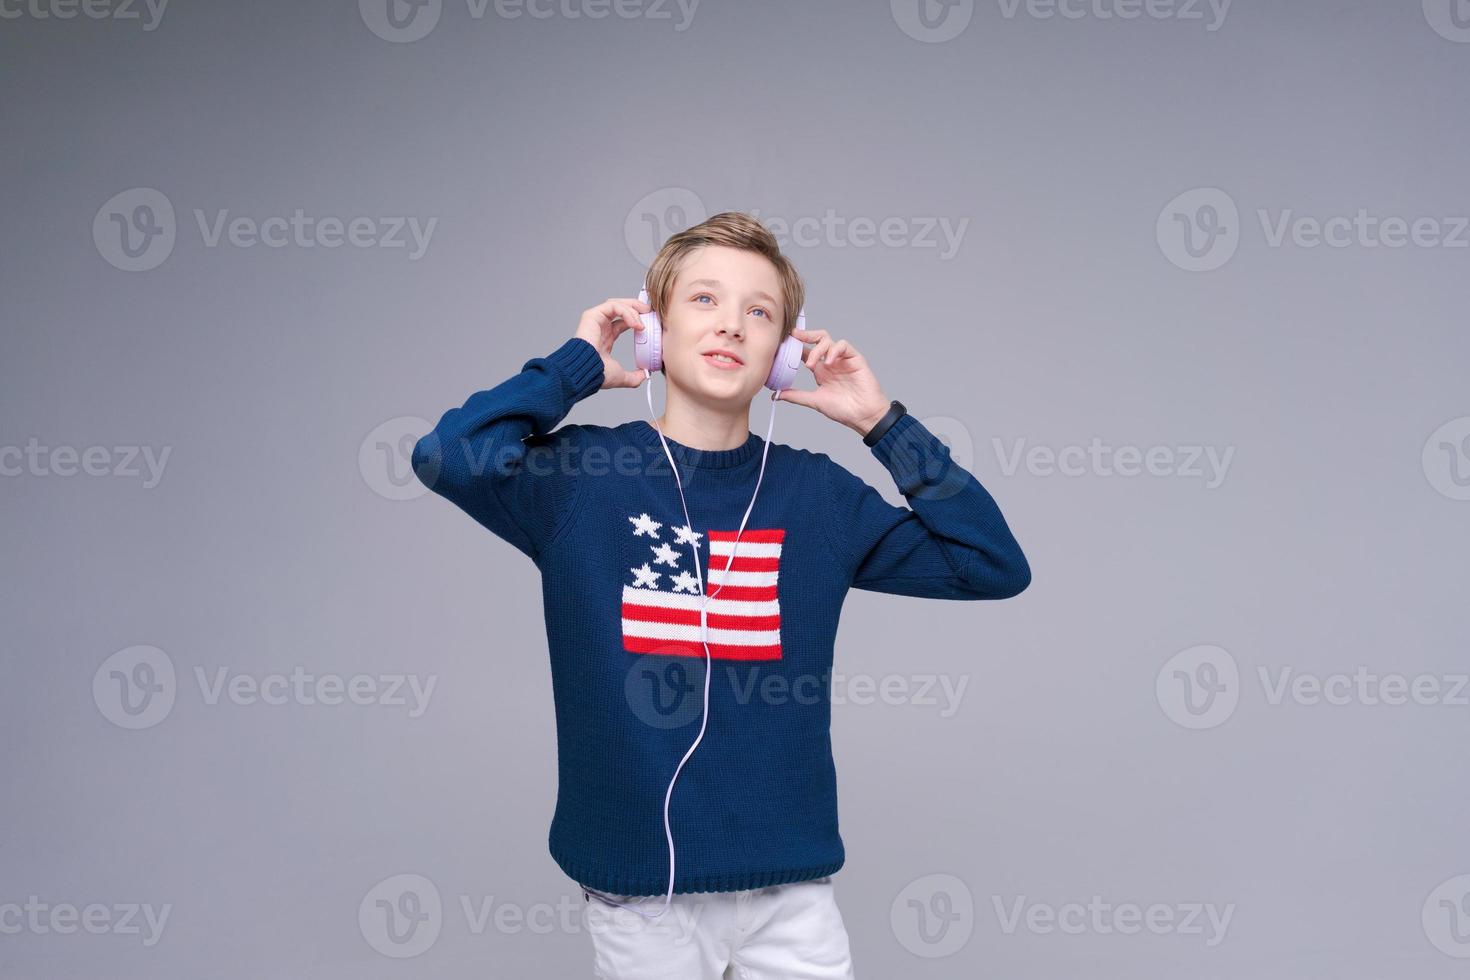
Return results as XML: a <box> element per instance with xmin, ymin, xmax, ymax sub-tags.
<box><xmin>1154</xmin><ymin>644</ymin><xmax>1470</xmax><ymax>729</ymax></box>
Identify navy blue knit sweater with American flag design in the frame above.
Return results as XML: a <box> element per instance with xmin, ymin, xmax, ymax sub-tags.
<box><xmin>413</xmin><ymin>338</ymin><xmax>1030</xmax><ymax>895</ymax></box>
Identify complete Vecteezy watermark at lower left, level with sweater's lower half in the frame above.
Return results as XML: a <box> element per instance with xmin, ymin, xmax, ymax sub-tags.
<box><xmin>93</xmin><ymin>645</ymin><xmax>438</xmax><ymax>730</ymax></box>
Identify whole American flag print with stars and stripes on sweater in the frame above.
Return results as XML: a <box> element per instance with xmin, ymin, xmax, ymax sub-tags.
<box><xmin>623</xmin><ymin>514</ymin><xmax>786</xmax><ymax>660</ymax></box>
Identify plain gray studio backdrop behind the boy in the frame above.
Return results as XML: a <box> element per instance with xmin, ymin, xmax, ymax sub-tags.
<box><xmin>0</xmin><ymin>0</ymin><xmax>1470</xmax><ymax>980</ymax></box>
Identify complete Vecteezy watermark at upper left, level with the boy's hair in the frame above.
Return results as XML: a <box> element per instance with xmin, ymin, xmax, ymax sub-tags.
<box><xmin>93</xmin><ymin>187</ymin><xmax>440</xmax><ymax>272</ymax></box>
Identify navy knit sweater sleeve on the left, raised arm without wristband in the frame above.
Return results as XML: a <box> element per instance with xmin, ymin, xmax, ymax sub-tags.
<box><xmin>412</xmin><ymin>336</ymin><xmax>603</xmax><ymax>560</ymax></box>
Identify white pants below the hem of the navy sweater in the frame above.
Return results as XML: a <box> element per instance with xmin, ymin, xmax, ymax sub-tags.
<box><xmin>582</xmin><ymin>876</ymin><xmax>853</xmax><ymax>980</ymax></box>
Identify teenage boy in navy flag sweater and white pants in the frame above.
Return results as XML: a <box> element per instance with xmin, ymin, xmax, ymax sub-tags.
<box><xmin>413</xmin><ymin>212</ymin><xmax>1030</xmax><ymax>980</ymax></box>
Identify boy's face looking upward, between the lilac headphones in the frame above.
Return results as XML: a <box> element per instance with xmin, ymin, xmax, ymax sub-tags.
<box><xmin>662</xmin><ymin>245</ymin><xmax>785</xmax><ymax>410</ymax></box>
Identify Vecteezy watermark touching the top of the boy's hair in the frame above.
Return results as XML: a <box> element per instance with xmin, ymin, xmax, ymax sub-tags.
<box><xmin>623</xmin><ymin>187</ymin><xmax>970</xmax><ymax>266</ymax></box>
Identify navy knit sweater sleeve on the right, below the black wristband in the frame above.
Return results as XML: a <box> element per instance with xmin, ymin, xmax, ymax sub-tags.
<box><xmin>825</xmin><ymin>414</ymin><xmax>1030</xmax><ymax>599</ymax></box>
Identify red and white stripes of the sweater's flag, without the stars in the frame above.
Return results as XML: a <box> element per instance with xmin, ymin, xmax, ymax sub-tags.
<box><xmin>623</xmin><ymin>527</ymin><xmax>786</xmax><ymax>660</ymax></box>
